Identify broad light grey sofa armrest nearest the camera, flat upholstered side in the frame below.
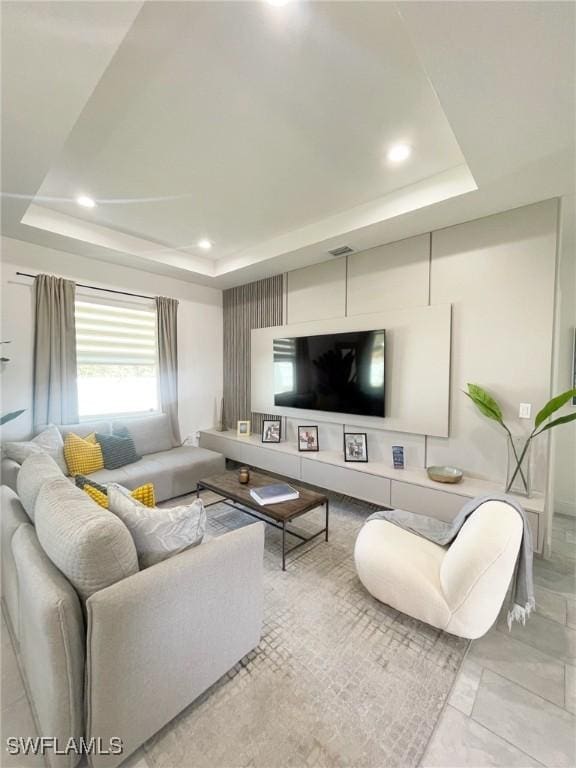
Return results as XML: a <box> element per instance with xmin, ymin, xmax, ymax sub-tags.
<box><xmin>86</xmin><ymin>523</ymin><xmax>264</xmax><ymax>768</ymax></box>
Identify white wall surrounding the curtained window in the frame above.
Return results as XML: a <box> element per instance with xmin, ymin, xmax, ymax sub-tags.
<box><xmin>0</xmin><ymin>237</ymin><xmax>222</xmax><ymax>439</ymax></box>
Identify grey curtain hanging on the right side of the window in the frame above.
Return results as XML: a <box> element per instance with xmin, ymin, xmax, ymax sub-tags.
<box><xmin>156</xmin><ymin>296</ymin><xmax>182</xmax><ymax>445</ymax></box>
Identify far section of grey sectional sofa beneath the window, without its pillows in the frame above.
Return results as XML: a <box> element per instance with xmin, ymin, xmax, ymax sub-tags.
<box><xmin>2</xmin><ymin>414</ymin><xmax>226</xmax><ymax>501</ymax></box>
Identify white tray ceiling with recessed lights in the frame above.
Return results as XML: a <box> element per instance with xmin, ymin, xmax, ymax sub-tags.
<box><xmin>2</xmin><ymin>0</ymin><xmax>575</xmax><ymax>287</ymax></box>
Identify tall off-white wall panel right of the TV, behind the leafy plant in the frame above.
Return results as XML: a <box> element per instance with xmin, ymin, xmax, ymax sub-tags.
<box><xmin>428</xmin><ymin>200</ymin><xmax>562</xmax><ymax>491</ymax></box>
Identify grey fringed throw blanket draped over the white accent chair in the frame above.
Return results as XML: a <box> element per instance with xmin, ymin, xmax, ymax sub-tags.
<box><xmin>366</xmin><ymin>494</ymin><xmax>536</xmax><ymax>629</ymax></box>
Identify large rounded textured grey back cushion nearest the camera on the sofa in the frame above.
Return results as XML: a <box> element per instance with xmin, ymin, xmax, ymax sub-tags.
<box><xmin>35</xmin><ymin>477</ymin><xmax>138</xmax><ymax>598</ymax></box>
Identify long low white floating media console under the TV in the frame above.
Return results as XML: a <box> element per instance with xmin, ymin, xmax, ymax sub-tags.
<box><xmin>200</xmin><ymin>429</ymin><xmax>545</xmax><ymax>554</ymax></box>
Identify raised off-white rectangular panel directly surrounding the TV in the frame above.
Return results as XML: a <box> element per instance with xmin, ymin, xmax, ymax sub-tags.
<box><xmin>251</xmin><ymin>304</ymin><xmax>451</xmax><ymax>437</ymax></box>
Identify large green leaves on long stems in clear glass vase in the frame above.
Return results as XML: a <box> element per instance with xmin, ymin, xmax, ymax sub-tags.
<box><xmin>464</xmin><ymin>384</ymin><xmax>576</xmax><ymax>493</ymax></box>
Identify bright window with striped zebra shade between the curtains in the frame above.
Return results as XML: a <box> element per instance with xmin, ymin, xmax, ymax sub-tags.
<box><xmin>76</xmin><ymin>299</ymin><xmax>158</xmax><ymax>419</ymax></box>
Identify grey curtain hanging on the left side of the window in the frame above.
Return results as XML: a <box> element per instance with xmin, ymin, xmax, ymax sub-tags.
<box><xmin>33</xmin><ymin>275</ymin><xmax>78</xmax><ymax>426</ymax></box>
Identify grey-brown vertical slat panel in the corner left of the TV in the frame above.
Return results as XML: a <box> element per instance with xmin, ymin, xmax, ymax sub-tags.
<box><xmin>223</xmin><ymin>275</ymin><xmax>284</xmax><ymax>432</ymax></box>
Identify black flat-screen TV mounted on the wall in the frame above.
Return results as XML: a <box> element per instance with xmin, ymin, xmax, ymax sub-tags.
<box><xmin>274</xmin><ymin>330</ymin><xmax>385</xmax><ymax>416</ymax></box>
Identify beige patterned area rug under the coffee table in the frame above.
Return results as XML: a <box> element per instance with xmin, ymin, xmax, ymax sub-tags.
<box><xmin>144</xmin><ymin>488</ymin><xmax>468</xmax><ymax>768</ymax></box>
